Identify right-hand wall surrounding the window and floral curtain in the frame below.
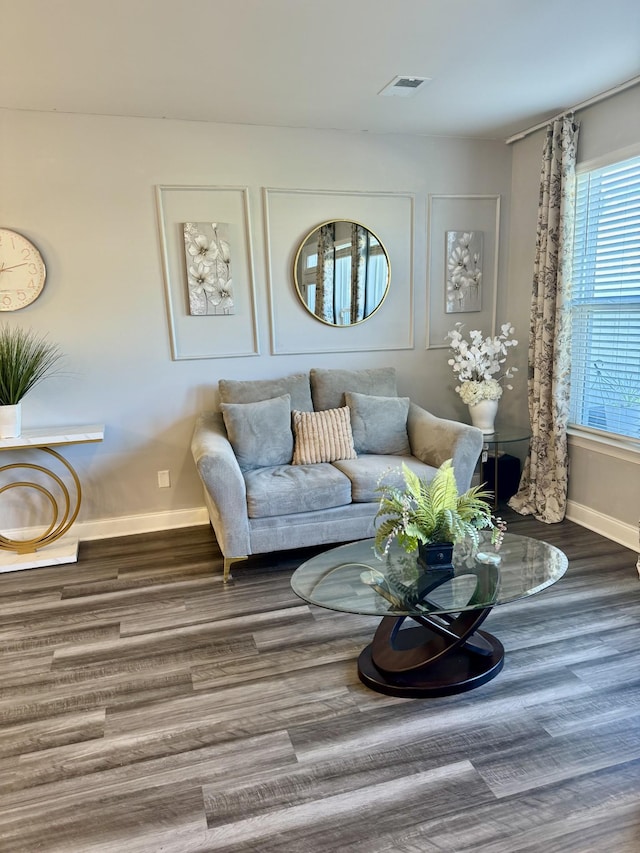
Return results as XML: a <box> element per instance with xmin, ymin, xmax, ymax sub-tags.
<box><xmin>506</xmin><ymin>86</ymin><xmax>640</xmax><ymax>547</ymax></box>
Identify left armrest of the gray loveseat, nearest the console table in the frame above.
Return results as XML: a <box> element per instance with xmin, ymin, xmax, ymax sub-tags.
<box><xmin>191</xmin><ymin>412</ymin><xmax>251</xmax><ymax>557</ymax></box>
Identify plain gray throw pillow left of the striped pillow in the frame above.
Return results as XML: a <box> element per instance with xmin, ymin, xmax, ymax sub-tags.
<box><xmin>220</xmin><ymin>394</ymin><xmax>293</xmax><ymax>471</ymax></box>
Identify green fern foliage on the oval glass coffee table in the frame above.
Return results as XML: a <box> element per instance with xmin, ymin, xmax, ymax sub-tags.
<box><xmin>375</xmin><ymin>459</ymin><xmax>495</xmax><ymax>554</ymax></box>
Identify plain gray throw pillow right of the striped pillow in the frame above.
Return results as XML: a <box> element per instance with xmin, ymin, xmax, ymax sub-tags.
<box><xmin>344</xmin><ymin>391</ymin><xmax>411</xmax><ymax>456</ymax></box>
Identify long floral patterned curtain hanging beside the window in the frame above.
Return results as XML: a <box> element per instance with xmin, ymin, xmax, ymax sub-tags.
<box><xmin>509</xmin><ymin>114</ymin><xmax>579</xmax><ymax>523</ymax></box>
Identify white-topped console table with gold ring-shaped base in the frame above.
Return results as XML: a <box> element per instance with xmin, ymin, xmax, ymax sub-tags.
<box><xmin>0</xmin><ymin>424</ymin><xmax>104</xmax><ymax>572</ymax></box>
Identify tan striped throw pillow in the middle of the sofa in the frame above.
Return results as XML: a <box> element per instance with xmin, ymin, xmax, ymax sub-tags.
<box><xmin>292</xmin><ymin>406</ymin><xmax>357</xmax><ymax>465</ymax></box>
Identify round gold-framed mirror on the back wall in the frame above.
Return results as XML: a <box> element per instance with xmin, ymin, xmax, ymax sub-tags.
<box><xmin>293</xmin><ymin>219</ymin><xmax>391</xmax><ymax>326</ymax></box>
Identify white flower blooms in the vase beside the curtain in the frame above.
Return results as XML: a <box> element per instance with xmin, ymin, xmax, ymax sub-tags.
<box><xmin>447</xmin><ymin>323</ymin><xmax>518</xmax><ymax>406</ymax></box>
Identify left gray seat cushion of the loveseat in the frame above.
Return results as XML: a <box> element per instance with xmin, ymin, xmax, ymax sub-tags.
<box><xmin>244</xmin><ymin>462</ymin><xmax>351</xmax><ymax>518</ymax></box>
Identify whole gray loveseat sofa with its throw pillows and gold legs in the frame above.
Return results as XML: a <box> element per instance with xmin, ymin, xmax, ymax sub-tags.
<box><xmin>191</xmin><ymin>368</ymin><xmax>482</xmax><ymax>580</ymax></box>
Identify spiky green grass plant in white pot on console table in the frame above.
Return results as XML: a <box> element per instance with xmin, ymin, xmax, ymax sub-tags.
<box><xmin>0</xmin><ymin>325</ymin><xmax>62</xmax><ymax>438</ymax></box>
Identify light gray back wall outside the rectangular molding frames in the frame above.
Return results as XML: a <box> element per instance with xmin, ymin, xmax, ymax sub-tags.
<box><xmin>0</xmin><ymin>110</ymin><xmax>510</xmax><ymax>533</ymax></box>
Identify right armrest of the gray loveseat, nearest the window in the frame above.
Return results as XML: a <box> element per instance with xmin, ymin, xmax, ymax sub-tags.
<box><xmin>407</xmin><ymin>403</ymin><xmax>483</xmax><ymax>492</ymax></box>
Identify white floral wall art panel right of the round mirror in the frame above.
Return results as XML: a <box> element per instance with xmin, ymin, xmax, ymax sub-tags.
<box><xmin>445</xmin><ymin>231</ymin><xmax>482</xmax><ymax>314</ymax></box>
